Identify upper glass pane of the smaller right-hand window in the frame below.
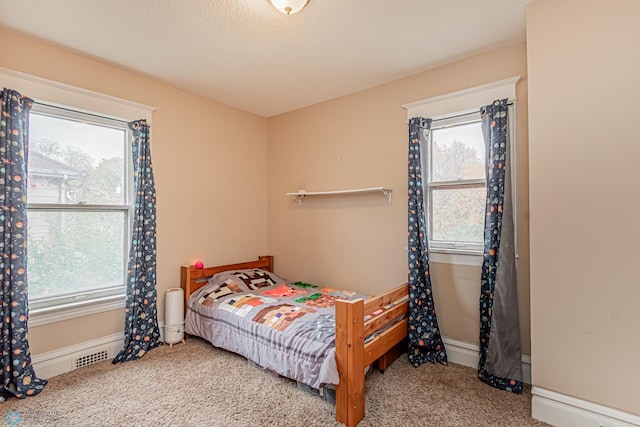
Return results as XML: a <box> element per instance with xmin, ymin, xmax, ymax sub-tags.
<box><xmin>430</xmin><ymin>122</ymin><xmax>485</xmax><ymax>182</ymax></box>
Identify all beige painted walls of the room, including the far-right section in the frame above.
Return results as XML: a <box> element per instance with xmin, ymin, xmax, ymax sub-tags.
<box><xmin>0</xmin><ymin>0</ymin><xmax>640</xmax><ymax>415</ymax></box>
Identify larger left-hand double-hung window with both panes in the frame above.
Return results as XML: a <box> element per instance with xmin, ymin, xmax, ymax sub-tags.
<box><xmin>27</xmin><ymin>103</ymin><xmax>133</xmax><ymax>309</ymax></box>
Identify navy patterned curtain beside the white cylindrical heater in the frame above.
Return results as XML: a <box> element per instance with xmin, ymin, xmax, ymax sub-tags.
<box><xmin>113</xmin><ymin>120</ymin><xmax>162</xmax><ymax>363</ymax></box>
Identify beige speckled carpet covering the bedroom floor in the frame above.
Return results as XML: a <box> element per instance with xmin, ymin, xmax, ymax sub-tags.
<box><xmin>0</xmin><ymin>338</ymin><xmax>546</xmax><ymax>427</ymax></box>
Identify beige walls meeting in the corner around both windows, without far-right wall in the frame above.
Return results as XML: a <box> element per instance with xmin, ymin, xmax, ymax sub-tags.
<box><xmin>0</xmin><ymin>25</ymin><xmax>530</xmax><ymax>378</ymax></box>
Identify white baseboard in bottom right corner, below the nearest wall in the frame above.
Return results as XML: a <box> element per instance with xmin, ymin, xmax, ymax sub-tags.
<box><xmin>531</xmin><ymin>387</ymin><xmax>640</xmax><ymax>427</ymax></box>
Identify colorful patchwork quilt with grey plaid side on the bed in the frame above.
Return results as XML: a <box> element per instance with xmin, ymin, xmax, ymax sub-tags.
<box><xmin>185</xmin><ymin>269</ymin><xmax>366</xmax><ymax>388</ymax></box>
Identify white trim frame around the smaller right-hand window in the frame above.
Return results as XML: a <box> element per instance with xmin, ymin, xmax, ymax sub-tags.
<box><xmin>402</xmin><ymin>76</ymin><xmax>520</xmax><ymax>266</ymax></box>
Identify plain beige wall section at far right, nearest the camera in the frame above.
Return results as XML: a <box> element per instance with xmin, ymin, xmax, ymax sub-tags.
<box><xmin>527</xmin><ymin>0</ymin><xmax>640</xmax><ymax>415</ymax></box>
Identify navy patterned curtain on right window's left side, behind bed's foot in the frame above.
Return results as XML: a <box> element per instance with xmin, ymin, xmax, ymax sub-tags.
<box><xmin>407</xmin><ymin>117</ymin><xmax>447</xmax><ymax>367</ymax></box>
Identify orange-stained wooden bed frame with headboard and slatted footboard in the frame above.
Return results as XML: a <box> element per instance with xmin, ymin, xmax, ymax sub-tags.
<box><xmin>180</xmin><ymin>255</ymin><xmax>409</xmax><ymax>427</ymax></box>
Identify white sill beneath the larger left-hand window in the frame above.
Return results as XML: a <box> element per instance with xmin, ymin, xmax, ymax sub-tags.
<box><xmin>29</xmin><ymin>295</ymin><xmax>126</xmax><ymax>328</ymax></box>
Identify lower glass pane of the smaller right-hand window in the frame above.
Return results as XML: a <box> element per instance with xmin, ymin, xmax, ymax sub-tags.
<box><xmin>431</xmin><ymin>188</ymin><xmax>487</xmax><ymax>243</ymax></box>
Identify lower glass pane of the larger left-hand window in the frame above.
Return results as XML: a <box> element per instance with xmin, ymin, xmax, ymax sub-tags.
<box><xmin>27</xmin><ymin>210</ymin><xmax>125</xmax><ymax>301</ymax></box>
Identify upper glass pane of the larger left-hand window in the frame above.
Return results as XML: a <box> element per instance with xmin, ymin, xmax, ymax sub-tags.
<box><xmin>27</xmin><ymin>112</ymin><xmax>126</xmax><ymax>205</ymax></box>
